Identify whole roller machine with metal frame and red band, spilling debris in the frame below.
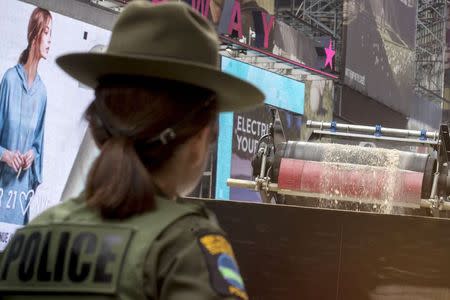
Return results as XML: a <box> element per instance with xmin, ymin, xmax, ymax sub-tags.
<box><xmin>228</xmin><ymin>116</ymin><xmax>450</xmax><ymax>212</ymax></box>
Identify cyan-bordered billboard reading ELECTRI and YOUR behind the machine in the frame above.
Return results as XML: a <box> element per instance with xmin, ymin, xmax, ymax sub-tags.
<box><xmin>216</xmin><ymin>57</ymin><xmax>305</xmax><ymax>202</ymax></box>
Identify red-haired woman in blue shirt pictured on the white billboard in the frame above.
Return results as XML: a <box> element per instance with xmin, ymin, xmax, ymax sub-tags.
<box><xmin>0</xmin><ymin>8</ymin><xmax>52</xmax><ymax>225</ymax></box>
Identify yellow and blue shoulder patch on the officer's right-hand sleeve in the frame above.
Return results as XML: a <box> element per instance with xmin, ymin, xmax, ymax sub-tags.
<box><xmin>198</xmin><ymin>233</ymin><xmax>248</xmax><ymax>300</ymax></box>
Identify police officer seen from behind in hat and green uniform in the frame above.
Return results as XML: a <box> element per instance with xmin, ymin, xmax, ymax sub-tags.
<box><xmin>0</xmin><ymin>1</ymin><xmax>263</xmax><ymax>300</ymax></box>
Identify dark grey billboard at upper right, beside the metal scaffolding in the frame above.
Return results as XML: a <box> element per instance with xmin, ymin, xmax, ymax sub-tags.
<box><xmin>344</xmin><ymin>0</ymin><xmax>417</xmax><ymax>115</ymax></box>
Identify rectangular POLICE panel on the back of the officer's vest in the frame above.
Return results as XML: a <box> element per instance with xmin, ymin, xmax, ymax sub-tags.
<box><xmin>0</xmin><ymin>224</ymin><xmax>133</xmax><ymax>295</ymax></box>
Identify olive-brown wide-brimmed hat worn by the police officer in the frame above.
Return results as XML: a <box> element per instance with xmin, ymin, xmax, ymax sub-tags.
<box><xmin>57</xmin><ymin>1</ymin><xmax>264</xmax><ymax>111</ymax></box>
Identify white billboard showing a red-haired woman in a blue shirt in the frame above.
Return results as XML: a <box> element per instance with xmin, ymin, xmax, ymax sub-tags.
<box><xmin>0</xmin><ymin>0</ymin><xmax>110</xmax><ymax>251</ymax></box>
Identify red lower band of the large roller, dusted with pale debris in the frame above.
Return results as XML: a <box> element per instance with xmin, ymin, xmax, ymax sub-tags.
<box><xmin>278</xmin><ymin>158</ymin><xmax>423</xmax><ymax>205</ymax></box>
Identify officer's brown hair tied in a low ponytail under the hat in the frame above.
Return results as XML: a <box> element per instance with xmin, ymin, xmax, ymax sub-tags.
<box><xmin>86</xmin><ymin>77</ymin><xmax>217</xmax><ymax>219</ymax></box>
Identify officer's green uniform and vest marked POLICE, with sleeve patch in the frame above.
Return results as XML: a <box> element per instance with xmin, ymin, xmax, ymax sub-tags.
<box><xmin>0</xmin><ymin>193</ymin><xmax>248</xmax><ymax>300</ymax></box>
